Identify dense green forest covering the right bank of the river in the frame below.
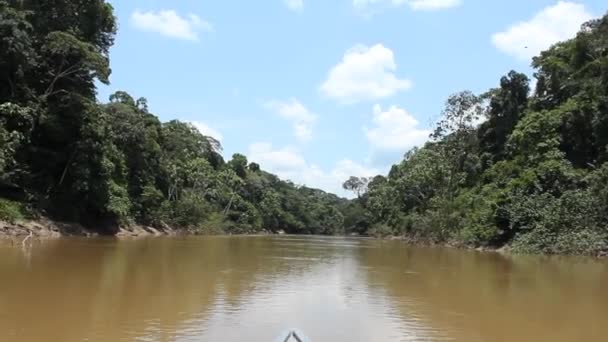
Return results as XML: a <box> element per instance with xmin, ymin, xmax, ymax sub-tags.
<box><xmin>345</xmin><ymin>16</ymin><xmax>608</xmax><ymax>255</ymax></box>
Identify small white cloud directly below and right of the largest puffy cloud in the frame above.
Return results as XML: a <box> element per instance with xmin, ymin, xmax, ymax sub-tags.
<box><xmin>363</xmin><ymin>105</ymin><xmax>431</xmax><ymax>151</ymax></box>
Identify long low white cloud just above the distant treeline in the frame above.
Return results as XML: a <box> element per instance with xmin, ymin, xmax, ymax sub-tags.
<box><xmin>248</xmin><ymin>143</ymin><xmax>380</xmax><ymax>197</ymax></box>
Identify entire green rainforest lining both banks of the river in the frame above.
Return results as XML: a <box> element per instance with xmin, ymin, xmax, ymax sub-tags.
<box><xmin>0</xmin><ymin>0</ymin><xmax>608</xmax><ymax>256</ymax></box>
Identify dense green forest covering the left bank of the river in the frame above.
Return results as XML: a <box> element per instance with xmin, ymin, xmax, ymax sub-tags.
<box><xmin>0</xmin><ymin>0</ymin><xmax>346</xmax><ymax>234</ymax></box>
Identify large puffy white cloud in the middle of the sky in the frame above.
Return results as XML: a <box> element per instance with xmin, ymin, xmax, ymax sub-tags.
<box><xmin>321</xmin><ymin>44</ymin><xmax>412</xmax><ymax>103</ymax></box>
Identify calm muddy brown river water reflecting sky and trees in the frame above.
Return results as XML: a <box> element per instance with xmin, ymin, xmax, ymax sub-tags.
<box><xmin>0</xmin><ymin>237</ymin><xmax>608</xmax><ymax>341</ymax></box>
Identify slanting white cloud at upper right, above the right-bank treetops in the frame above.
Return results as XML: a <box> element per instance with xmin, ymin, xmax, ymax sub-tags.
<box><xmin>492</xmin><ymin>1</ymin><xmax>593</xmax><ymax>61</ymax></box>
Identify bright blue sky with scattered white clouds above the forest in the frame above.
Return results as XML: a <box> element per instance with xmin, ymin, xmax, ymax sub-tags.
<box><xmin>98</xmin><ymin>0</ymin><xmax>608</xmax><ymax>196</ymax></box>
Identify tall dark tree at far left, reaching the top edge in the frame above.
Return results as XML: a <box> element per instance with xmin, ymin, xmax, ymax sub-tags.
<box><xmin>0</xmin><ymin>0</ymin><xmax>122</xmax><ymax>223</ymax></box>
